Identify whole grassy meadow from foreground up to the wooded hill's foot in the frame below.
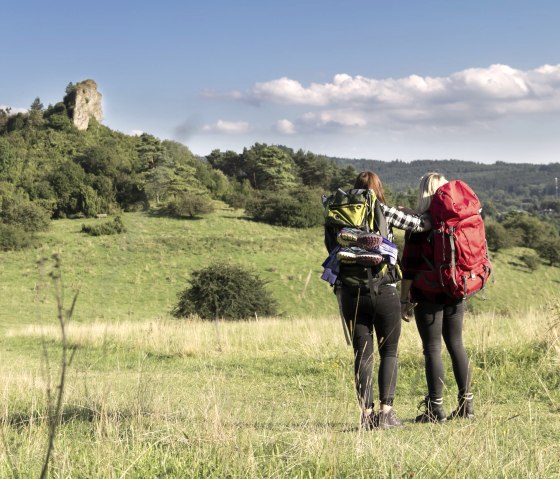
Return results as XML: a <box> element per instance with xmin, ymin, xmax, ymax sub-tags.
<box><xmin>0</xmin><ymin>209</ymin><xmax>560</xmax><ymax>478</ymax></box>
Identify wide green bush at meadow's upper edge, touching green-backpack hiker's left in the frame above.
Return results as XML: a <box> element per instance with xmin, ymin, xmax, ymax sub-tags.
<box><xmin>245</xmin><ymin>189</ymin><xmax>324</xmax><ymax>228</ymax></box>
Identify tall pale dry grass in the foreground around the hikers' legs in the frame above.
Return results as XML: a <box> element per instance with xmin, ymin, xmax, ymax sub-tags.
<box><xmin>0</xmin><ymin>311</ymin><xmax>560</xmax><ymax>478</ymax></box>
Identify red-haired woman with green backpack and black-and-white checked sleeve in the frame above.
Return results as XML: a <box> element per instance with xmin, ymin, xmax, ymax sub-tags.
<box><xmin>323</xmin><ymin>171</ymin><xmax>431</xmax><ymax>430</ymax></box>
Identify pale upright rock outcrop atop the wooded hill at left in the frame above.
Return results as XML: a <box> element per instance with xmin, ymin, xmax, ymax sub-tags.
<box><xmin>64</xmin><ymin>80</ymin><xmax>103</xmax><ymax>130</ymax></box>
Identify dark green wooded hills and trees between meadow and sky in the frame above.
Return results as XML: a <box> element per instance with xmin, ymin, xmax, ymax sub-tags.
<box><xmin>0</xmin><ymin>88</ymin><xmax>560</xmax><ymax>268</ymax></box>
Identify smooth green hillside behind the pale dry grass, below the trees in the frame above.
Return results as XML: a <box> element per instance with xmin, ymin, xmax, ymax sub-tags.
<box><xmin>0</xmin><ymin>204</ymin><xmax>560</xmax><ymax>327</ymax></box>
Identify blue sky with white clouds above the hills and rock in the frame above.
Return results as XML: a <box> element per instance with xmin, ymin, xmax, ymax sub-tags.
<box><xmin>0</xmin><ymin>0</ymin><xmax>560</xmax><ymax>163</ymax></box>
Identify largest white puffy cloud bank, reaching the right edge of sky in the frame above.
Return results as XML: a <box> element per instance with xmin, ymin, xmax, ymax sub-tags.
<box><xmin>224</xmin><ymin>64</ymin><xmax>560</xmax><ymax>131</ymax></box>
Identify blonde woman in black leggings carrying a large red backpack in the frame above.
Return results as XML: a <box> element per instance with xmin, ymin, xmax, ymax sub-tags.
<box><xmin>401</xmin><ymin>173</ymin><xmax>491</xmax><ymax>423</ymax></box>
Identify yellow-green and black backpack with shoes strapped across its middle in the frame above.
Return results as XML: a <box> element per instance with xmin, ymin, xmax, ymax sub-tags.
<box><xmin>324</xmin><ymin>188</ymin><xmax>402</xmax><ymax>293</ymax></box>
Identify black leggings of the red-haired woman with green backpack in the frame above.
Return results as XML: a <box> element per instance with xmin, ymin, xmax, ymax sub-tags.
<box><xmin>341</xmin><ymin>285</ymin><xmax>401</xmax><ymax>408</ymax></box>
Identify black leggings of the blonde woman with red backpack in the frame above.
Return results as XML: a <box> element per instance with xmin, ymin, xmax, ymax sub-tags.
<box><xmin>414</xmin><ymin>301</ymin><xmax>471</xmax><ymax>399</ymax></box>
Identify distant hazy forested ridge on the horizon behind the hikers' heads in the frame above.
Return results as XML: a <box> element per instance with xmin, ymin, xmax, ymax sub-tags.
<box><xmin>333</xmin><ymin>158</ymin><xmax>560</xmax><ymax>209</ymax></box>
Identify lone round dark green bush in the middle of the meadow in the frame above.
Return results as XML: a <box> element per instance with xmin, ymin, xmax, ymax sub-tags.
<box><xmin>171</xmin><ymin>264</ymin><xmax>276</xmax><ymax>320</ymax></box>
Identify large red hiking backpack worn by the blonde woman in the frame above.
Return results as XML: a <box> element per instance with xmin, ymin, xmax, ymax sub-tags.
<box><xmin>414</xmin><ymin>180</ymin><xmax>492</xmax><ymax>298</ymax></box>
